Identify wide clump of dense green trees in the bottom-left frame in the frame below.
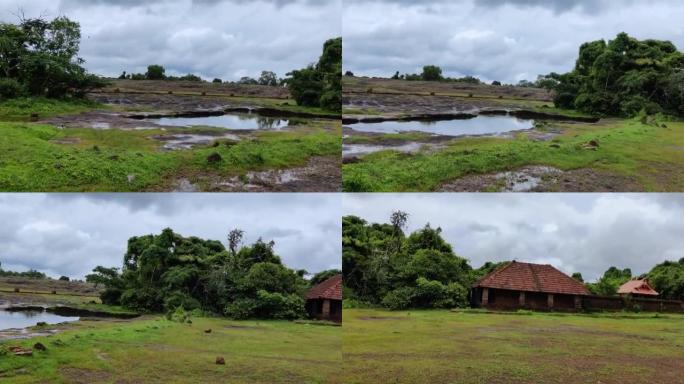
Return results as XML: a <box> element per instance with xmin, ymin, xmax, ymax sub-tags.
<box><xmin>86</xmin><ymin>228</ymin><xmax>307</xmax><ymax>319</ymax></box>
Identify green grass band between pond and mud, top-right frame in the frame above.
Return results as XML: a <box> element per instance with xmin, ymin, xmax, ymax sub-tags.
<box><xmin>342</xmin><ymin>120</ymin><xmax>684</xmax><ymax>192</ymax></box>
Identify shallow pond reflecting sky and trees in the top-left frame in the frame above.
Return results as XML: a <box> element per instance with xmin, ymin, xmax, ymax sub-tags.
<box><xmin>149</xmin><ymin>113</ymin><xmax>290</xmax><ymax>130</ymax></box>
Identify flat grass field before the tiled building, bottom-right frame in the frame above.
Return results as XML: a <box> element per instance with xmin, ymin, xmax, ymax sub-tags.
<box><xmin>342</xmin><ymin>309</ymin><xmax>684</xmax><ymax>384</ymax></box>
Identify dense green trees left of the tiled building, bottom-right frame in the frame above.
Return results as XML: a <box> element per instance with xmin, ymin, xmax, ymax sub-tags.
<box><xmin>342</xmin><ymin>212</ymin><xmax>504</xmax><ymax>309</ymax></box>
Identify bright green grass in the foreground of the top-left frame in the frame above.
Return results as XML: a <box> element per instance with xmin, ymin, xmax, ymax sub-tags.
<box><xmin>0</xmin><ymin>122</ymin><xmax>341</xmax><ymax>192</ymax></box>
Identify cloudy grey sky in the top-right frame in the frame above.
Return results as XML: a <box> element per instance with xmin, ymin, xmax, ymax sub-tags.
<box><xmin>343</xmin><ymin>0</ymin><xmax>684</xmax><ymax>83</ymax></box>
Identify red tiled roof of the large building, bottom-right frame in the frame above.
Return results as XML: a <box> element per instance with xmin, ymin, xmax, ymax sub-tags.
<box><xmin>473</xmin><ymin>261</ymin><xmax>589</xmax><ymax>295</ymax></box>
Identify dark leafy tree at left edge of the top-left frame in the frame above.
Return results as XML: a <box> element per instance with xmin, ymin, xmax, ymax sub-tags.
<box><xmin>0</xmin><ymin>17</ymin><xmax>105</xmax><ymax>99</ymax></box>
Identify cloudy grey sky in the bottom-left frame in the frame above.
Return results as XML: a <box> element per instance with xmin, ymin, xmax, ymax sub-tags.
<box><xmin>0</xmin><ymin>193</ymin><xmax>342</xmax><ymax>278</ymax></box>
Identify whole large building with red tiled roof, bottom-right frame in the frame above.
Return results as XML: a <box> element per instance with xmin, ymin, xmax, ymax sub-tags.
<box><xmin>471</xmin><ymin>261</ymin><xmax>589</xmax><ymax>311</ymax></box>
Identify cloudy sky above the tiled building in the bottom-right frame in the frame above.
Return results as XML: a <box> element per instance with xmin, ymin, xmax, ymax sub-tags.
<box><xmin>343</xmin><ymin>193</ymin><xmax>684</xmax><ymax>281</ymax></box>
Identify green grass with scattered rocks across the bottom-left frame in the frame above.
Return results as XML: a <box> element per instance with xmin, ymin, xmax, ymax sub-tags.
<box><xmin>0</xmin><ymin>318</ymin><xmax>342</xmax><ymax>384</ymax></box>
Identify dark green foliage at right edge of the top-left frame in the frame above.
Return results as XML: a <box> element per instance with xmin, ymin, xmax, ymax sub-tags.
<box><xmin>286</xmin><ymin>37</ymin><xmax>342</xmax><ymax>112</ymax></box>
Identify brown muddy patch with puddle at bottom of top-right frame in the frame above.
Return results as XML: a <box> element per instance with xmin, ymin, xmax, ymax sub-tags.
<box><xmin>438</xmin><ymin>166</ymin><xmax>643</xmax><ymax>192</ymax></box>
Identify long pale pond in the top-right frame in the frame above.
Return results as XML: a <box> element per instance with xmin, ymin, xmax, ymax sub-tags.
<box><xmin>349</xmin><ymin>116</ymin><xmax>534</xmax><ymax>136</ymax></box>
